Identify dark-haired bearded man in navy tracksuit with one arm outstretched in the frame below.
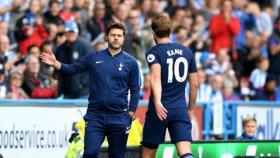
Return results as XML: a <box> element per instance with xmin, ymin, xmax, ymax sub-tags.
<box><xmin>41</xmin><ymin>23</ymin><xmax>141</xmax><ymax>158</ymax></box>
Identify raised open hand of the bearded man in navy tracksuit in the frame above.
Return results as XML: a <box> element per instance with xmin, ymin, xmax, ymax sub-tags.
<box><xmin>40</xmin><ymin>50</ymin><xmax>61</xmax><ymax>70</ymax></box>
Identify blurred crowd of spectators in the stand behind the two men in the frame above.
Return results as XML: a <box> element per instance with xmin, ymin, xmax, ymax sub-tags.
<box><xmin>0</xmin><ymin>0</ymin><xmax>280</xmax><ymax>102</ymax></box>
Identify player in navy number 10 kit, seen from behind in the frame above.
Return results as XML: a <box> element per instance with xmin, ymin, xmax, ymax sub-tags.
<box><xmin>141</xmin><ymin>15</ymin><xmax>198</xmax><ymax>158</ymax></box>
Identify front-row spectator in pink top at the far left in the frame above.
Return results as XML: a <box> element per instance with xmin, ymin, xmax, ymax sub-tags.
<box><xmin>6</xmin><ymin>68</ymin><xmax>29</xmax><ymax>99</ymax></box>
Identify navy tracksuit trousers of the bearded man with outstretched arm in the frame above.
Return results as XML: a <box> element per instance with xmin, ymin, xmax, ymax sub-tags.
<box><xmin>83</xmin><ymin>112</ymin><xmax>132</xmax><ymax>158</ymax></box>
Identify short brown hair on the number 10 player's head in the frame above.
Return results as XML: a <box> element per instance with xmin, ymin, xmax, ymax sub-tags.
<box><xmin>152</xmin><ymin>14</ymin><xmax>172</xmax><ymax>38</ymax></box>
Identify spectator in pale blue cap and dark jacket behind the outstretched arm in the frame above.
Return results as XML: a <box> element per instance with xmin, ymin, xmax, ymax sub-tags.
<box><xmin>55</xmin><ymin>21</ymin><xmax>92</xmax><ymax>98</ymax></box>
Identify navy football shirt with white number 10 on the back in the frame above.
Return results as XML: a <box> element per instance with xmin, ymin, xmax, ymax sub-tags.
<box><xmin>146</xmin><ymin>43</ymin><xmax>196</xmax><ymax>110</ymax></box>
